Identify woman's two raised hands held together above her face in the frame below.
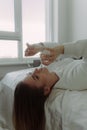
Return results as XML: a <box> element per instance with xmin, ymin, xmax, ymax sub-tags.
<box><xmin>25</xmin><ymin>42</ymin><xmax>64</xmax><ymax>65</ymax></box>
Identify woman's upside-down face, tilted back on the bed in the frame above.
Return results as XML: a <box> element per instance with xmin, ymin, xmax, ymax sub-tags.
<box><xmin>24</xmin><ymin>68</ymin><xmax>51</xmax><ymax>88</ymax></box>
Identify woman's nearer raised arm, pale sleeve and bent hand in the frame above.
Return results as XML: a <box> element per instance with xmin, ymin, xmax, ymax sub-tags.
<box><xmin>41</xmin><ymin>39</ymin><xmax>87</xmax><ymax>65</ymax></box>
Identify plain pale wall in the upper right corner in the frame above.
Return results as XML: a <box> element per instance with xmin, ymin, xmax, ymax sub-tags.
<box><xmin>67</xmin><ymin>0</ymin><xmax>87</xmax><ymax>41</ymax></box>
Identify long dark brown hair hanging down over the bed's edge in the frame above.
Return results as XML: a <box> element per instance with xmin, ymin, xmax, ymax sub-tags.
<box><xmin>13</xmin><ymin>81</ymin><xmax>47</xmax><ymax>130</ymax></box>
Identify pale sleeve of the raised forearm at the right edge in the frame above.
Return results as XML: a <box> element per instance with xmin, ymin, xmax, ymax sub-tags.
<box><xmin>64</xmin><ymin>39</ymin><xmax>87</xmax><ymax>57</ymax></box>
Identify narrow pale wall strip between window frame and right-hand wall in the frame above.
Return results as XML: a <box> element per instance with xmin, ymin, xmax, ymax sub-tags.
<box><xmin>58</xmin><ymin>0</ymin><xmax>68</xmax><ymax>43</ymax></box>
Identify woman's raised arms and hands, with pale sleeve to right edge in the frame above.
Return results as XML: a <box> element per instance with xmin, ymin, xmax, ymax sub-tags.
<box><xmin>25</xmin><ymin>39</ymin><xmax>87</xmax><ymax>65</ymax></box>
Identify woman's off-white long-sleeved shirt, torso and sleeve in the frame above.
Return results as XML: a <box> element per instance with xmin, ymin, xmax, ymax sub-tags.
<box><xmin>45</xmin><ymin>40</ymin><xmax>87</xmax><ymax>90</ymax></box>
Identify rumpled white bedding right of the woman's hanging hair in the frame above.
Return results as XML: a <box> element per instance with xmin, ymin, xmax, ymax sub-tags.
<box><xmin>45</xmin><ymin>89</ymin><xmax>87</xmax><ymax>130</ymax></box>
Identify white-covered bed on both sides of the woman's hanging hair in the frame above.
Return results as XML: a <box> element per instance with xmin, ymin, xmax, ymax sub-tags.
<box><xmin>0</xmin><ymin>68</ymin><xmax>87</xmax><ymax>130</ymax></box>
